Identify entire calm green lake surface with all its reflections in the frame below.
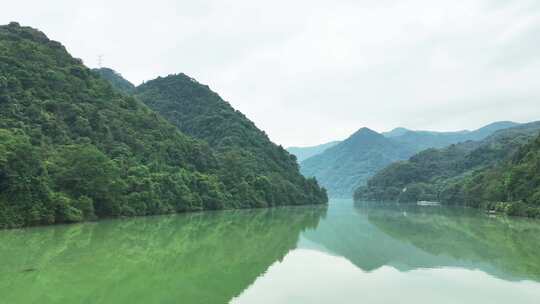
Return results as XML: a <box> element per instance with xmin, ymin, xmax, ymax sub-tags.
<box><xmin>0</xmin><ymin>201</ymin><xmax>540</xmax><ymax>304</ymax></box>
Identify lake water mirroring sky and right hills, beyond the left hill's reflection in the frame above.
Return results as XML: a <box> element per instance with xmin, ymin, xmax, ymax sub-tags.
<box><xmin>232</xmin><ymin>201</ymin><xmax>540</xmax><ymax>304</ymax></box>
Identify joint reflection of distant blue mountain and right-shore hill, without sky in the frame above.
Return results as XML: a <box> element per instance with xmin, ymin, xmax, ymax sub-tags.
<box><xmin>301</xmin><ymin>201</ymin><xmax>540</xmax><ymax>281</ymax></box>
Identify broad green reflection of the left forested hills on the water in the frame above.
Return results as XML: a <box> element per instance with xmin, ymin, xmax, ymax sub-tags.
<box><xmin>0</xmin><ymin>207</ymin><xmax>326</xmax><ymax>303</ymax></box>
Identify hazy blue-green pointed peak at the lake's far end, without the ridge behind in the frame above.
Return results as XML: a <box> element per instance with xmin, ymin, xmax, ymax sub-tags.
<box><xmin>301</xmin><ymin>128</ymin><xmax>413</xmax><ymax>197</ymax></box>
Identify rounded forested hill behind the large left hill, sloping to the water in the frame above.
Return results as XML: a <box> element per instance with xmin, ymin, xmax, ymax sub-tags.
<box><xmin>135</xmin><ymin>74</ymin><xmax>327</xmax><ymax>206</ymax></box>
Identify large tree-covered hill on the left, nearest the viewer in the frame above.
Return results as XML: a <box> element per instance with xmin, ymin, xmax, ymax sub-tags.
<box><xmin>0</xmin><ymin>23</ymin><xmax>326</xmax><ymax>227</ymax></box>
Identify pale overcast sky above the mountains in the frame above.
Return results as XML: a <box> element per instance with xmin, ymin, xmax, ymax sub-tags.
<box><xmin>0</xmin><ymin>0</ymin><xmax>540</xmax><ymax>146</ymax></box>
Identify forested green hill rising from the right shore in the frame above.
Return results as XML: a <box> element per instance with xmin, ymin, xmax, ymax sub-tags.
<box><xmin>355</xmin><ymin>122</ymin><xmax>540</xmax><ymax>217</ymax></box>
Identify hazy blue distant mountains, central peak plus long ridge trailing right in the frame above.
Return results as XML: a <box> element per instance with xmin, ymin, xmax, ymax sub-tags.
<box><xmin>300</xmin><ymin>122</ymin><xmax>518</xmax><ymax>197</ymax></box>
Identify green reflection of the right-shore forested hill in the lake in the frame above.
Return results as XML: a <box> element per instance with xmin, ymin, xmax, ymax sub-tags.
<box><xmin>356</xmin><ymin>204</ymin><xmax>540</xmax><ymax>281</ymax></box>
